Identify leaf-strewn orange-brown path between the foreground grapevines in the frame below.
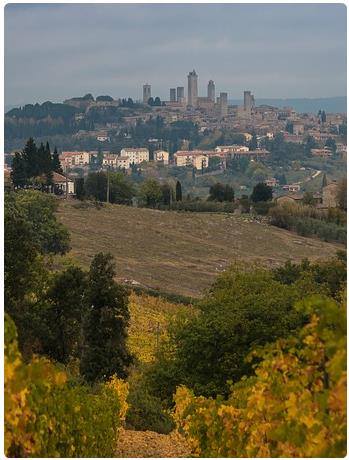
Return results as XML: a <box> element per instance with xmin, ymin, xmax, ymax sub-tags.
<box><xmin>115</xmin><ymin>429</ymin><xmax>192</xmax><ymax>458</ymax></box>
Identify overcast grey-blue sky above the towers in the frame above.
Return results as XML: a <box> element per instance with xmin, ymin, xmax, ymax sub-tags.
<box><xmin>5</xmin><ymin>3</ymin><xmax>347</xmax><ymax>106</ymax></box>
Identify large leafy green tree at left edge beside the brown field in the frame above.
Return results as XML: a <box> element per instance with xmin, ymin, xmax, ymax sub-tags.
<box><xmin>5</xmin><ymin>191</ymin><xmax>69</xmax><ymax>356</ymax></box>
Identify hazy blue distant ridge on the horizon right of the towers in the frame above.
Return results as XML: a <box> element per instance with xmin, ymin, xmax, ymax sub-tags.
<box><xmin>229</xmin><ymin>96</ymin><xmax>347</xmax><ymax>113</ymax></box>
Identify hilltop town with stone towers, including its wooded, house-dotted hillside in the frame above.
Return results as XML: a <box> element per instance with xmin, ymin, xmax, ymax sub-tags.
<box><xmin>5</xmin><ymin>70</ymin><xmax>347</xmax><ymax>207</ymax></box>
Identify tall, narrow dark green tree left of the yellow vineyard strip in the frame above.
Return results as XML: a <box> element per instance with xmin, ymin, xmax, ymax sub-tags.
<box><xmin>80</xmin><ymin>253</ymin><xmax>131</xmax><ymax>382</ymax></box>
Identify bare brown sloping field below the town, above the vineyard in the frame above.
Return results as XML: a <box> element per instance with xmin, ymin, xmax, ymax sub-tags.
<box><xmin>58</xmin><ymin>200</ymin><xmax>339</xmax><ymax>297</ymax></box>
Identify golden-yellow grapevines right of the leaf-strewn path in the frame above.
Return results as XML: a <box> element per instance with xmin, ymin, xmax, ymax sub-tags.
<box><xmin>175</xmin><ymin>297</ymin><xmax>346</xmax><ymax>457</ymax></box>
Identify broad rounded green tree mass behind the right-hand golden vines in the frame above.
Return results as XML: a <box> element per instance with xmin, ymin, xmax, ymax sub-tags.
<box><xmin>147</xmin><ymin>267</ymin><xmax>319</xmax><ymax>403</ymax></box>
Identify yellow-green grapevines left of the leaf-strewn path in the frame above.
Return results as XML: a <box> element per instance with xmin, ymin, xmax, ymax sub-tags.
<box><xmin>5</xmin><ymin>315</ymin><xmax>128</xmax><ymax>457</ymax></box>
